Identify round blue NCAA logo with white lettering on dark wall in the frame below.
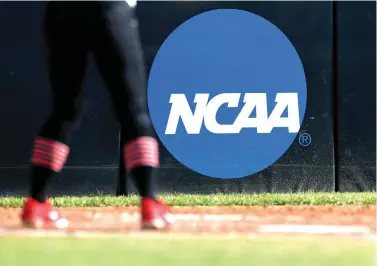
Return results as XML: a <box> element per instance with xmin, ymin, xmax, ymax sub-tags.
<box><xmin>148</xmin><ymin>9</ymin><xmax>306</xmax><ymax>179</ymax></box>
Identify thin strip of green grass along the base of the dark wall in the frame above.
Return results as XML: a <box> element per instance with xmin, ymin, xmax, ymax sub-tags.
<box><xmin>0</xmin><ymin>192</ymin><xmax>376</xmax><ymax>207</ymax></box>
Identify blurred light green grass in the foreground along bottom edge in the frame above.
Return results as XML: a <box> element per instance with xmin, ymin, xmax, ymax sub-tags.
<box><xmin>0</xmin><ymin>237</ymin><xmax>376</xmax><ymax>266</ymax></box>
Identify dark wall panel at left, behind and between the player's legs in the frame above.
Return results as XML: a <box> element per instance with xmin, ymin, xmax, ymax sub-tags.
<box><xmin>0</xmin><ymin>2</ymin><xmax>118</xmax><ymax>195</ymax></box>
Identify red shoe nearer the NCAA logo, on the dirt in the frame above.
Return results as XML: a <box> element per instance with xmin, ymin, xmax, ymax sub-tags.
<box><xmin>141</xmin><ymin>198</ymin><xmax>175</xmax><ymax>230</ymax></box>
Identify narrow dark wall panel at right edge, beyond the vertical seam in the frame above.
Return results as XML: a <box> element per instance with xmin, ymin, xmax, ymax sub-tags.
<box><xmin>337</xmin><ymin>1</ymin><xmax>376</xmax><ymax>191</ymax></box>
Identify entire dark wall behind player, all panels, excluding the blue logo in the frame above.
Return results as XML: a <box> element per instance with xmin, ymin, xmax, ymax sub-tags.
<box><xmin>0</xmin><ymin>2</ymin><xmax>376</xmax><ymax>195</ymax></box>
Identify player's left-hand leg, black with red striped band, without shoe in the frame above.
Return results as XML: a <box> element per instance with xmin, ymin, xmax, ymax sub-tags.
<box><xmin>30</xmin><ymin>2</ymin><xmax>87</xmax><ymax>202</ymax></box>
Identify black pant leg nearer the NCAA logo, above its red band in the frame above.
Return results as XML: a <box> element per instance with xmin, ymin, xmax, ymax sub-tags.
<box><xmin>94</xmin><ymin>1</ymin><xmax>154</xmax><ymax>141</ymax></box>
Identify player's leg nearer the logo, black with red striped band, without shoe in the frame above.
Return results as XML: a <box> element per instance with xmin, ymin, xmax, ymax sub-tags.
<box><xmin>94</xmin><ymin>1</ymin><xmax>159</xmax><ymax>202</ymax></box>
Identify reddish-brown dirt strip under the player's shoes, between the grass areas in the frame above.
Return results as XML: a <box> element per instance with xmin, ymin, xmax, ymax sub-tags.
<box><xmin>0</xmin><ymin>205</ymin><xmax>376</xmax><ymax>234</ymax></box>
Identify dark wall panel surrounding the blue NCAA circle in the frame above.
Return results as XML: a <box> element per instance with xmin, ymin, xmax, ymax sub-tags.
<box><xmin>133</xmin><ymin>2</ymin><xmax>334</xmax><ymax>193</ymax></box>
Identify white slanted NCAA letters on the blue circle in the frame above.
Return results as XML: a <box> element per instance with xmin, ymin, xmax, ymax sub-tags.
<box><xmin>165</xmin><ymin>93</ymin><xmax>300</xmax><ymax>135</ymax></box>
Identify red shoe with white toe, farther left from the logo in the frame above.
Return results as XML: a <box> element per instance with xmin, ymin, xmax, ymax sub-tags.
<box><xmin>21</xmin><ymin>198</ymin><xmax>69</xmax><ymax>229</ymax></box>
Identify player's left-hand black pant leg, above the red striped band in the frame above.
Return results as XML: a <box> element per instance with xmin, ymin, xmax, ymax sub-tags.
<box><xmin>40</xmin><ymin>2</ymin><xmax>87</xmax><ymax>142</ymax></box>
